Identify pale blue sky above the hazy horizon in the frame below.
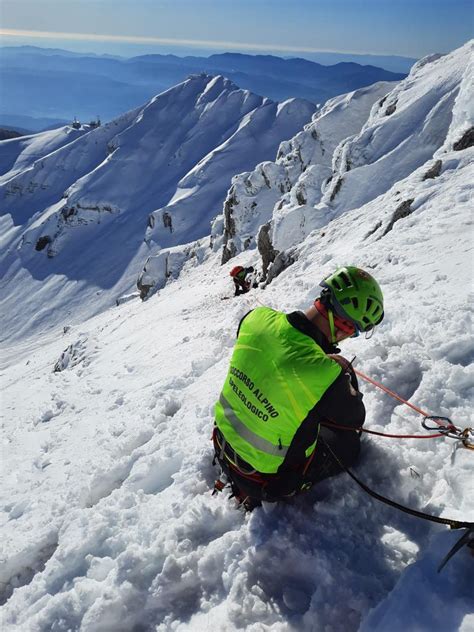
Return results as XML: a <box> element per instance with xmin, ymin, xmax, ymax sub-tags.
<box><xmin>0</xmin><ymin>0</ymin><xmax>474</xmax><ymax>57</ymax></box>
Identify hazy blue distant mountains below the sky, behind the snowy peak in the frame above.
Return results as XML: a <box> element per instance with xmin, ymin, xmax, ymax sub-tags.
<box><xmin>0</xmin><ymin>46</ymin><xmax>405</xmax><ymax>131</ymax></box>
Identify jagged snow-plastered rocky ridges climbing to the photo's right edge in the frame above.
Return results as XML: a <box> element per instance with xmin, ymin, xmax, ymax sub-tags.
<box><xmin>214</xmin><ymin>42</ymin><xmax>473</xmax><ymax>282</ymax></box>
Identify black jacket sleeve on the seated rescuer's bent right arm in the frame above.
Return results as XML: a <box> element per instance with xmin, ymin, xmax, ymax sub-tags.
<box><xmin>312</xmin><ymin>371</ymin><xmax>365</xmax><ymax>428</ymax></box>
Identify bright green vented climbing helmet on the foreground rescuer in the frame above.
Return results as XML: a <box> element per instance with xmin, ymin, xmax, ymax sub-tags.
<box><xmin>320</xmin><ymin>266</ymin><xmax>383</xmax><ymax>331</ymax></box>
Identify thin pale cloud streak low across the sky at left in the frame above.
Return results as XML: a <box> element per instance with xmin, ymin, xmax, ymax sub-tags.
<box><xmin>0</xmin><ymin>29</ymin><xmax>350</xmax><ymax>53</ymax></box>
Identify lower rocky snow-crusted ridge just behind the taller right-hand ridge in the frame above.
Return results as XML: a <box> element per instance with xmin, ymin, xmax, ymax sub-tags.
<box><xmin>215</xmin><ymin>83</ymin><xmax>393</xmax><ymax>270</ymax></box>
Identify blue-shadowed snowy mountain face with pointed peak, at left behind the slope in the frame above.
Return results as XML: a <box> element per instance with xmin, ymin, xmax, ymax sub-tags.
<box><xmin>0</xmin><ymin>74</ymin><xmax>315</xmax><ymax>346</ymax></box>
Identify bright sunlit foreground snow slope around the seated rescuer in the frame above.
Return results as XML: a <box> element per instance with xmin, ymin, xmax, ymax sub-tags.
<box><xmin>0</xmin><ymin>42</ymin><xmax>474</xmax><ymax>632</ymax></box>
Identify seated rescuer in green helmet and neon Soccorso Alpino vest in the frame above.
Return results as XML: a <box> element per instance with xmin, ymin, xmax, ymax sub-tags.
<box><xmin>213</xmin><ymin>266</ymin><xmax>383</xmax><ymax>510</ymax></box>
